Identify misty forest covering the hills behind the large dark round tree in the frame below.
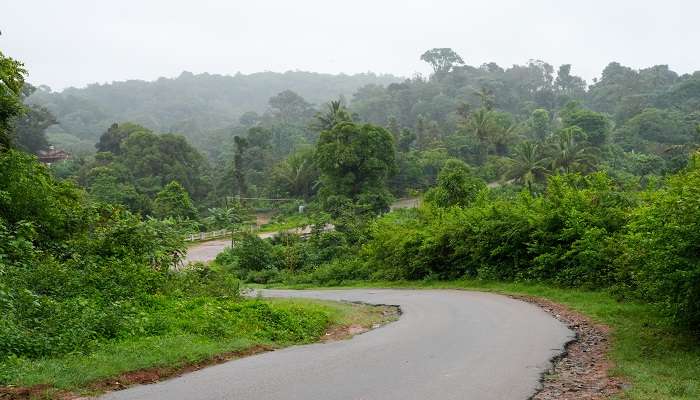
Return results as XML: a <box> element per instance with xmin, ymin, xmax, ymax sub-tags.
<box><xmin>16</xmin><ymin>49</ymin><xmax>700</xmax><ymax>223</ymax></box>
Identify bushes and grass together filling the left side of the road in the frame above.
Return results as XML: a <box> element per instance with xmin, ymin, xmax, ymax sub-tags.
<box><xmin>0</xmin><ymin>55</ymin><xmax>383</xmax><ymax>398</ymax></box>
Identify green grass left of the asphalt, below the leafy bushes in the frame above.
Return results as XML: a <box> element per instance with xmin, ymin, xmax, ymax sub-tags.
<box><xmin>0</xmin><ymin>299</ymin><xmax>384</xmax><ymax>393</ymax></box>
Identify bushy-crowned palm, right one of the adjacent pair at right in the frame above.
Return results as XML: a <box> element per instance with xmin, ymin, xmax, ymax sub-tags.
<box><xmin>551</xmin><ymin>127</ymin><xmax>598</xmax><ymax>173</ymax></box>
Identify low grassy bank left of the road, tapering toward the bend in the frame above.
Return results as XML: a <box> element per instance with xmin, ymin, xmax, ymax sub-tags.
<box><xmin>0</xmin><ymin>299</ymin><xmax>388</xmax><ymax>398</ymax></box>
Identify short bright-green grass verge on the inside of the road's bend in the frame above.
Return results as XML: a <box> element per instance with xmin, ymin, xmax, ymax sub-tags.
<box><xmin>0</xmin><ymin>299</ymin><xmax>392</xmax><ymax>399</ymax></box>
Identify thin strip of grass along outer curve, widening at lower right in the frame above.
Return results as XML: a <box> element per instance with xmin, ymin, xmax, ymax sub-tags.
<box><xmin>262</xmin><ymin>280</ymin><xmax>700</xmax><ymax>400</ymax></box>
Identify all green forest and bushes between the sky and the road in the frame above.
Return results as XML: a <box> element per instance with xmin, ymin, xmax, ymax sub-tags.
<box><xmin>0</xmin><ymin>48</ymin><xmax>700</xmax><ymax>396</ymax></box>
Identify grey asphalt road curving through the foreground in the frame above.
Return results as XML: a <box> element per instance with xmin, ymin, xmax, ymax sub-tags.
<box><xmin>103</xmin><ymin>289</ymin><xmax>573</xmax><ymax>400</ymax></box>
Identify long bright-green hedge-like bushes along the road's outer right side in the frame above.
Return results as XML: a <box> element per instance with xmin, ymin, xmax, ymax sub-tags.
<box><xmin>352</xmin><ymin>164</ymin><xmax>700</xmax><ymax>330</ymax></box>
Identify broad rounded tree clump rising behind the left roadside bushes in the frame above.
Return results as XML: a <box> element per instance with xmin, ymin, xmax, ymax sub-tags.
<box><xmin>78</xmin><ymin>123</ymin><xmax>209</xmax><ymax>214</ymax></box>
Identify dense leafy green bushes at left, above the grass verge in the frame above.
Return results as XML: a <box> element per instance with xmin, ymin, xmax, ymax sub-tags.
<box><xmin>0</xmin><ymin>150</ymin><xmax>190</xmax><ymax>359</ymax></box>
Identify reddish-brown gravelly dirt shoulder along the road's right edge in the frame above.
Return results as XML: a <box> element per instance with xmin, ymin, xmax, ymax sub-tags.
<box><xmin>511</xmin><ymin>296</ymin><xmax>624</xmax><ymax>400</ymax></box>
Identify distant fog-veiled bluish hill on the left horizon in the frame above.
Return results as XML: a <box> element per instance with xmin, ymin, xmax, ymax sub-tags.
<box><xmin>30</xmin><ymin>71</ymin><xmax>401</xmax><ymax>143</ymax></box>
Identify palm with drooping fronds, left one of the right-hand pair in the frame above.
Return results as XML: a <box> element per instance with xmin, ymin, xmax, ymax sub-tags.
<box><xmin>506</xmin><ymin>141</ymin><xmax>549</xmax><ymax>194</ymax></box>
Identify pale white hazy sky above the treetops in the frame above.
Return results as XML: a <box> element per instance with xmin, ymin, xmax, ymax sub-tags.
<box><xmin>0</xmin><ymin>0</ymin><xmax>700</xmax><ymax>89</ymax></box>
